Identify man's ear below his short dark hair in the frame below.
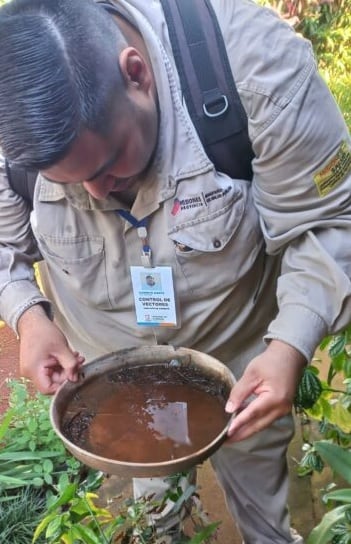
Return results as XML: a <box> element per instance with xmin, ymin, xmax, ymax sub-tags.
<box><xmin>119</xmin><ymin>47</ymin><xmax>151</xmax><ymax>90</ymax></box>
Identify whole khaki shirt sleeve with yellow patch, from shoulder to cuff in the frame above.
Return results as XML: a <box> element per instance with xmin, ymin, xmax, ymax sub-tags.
<box><xmin>206</xmin><ymin>0</ymin><xmax>351</xmax><ymax>360</ymax></box>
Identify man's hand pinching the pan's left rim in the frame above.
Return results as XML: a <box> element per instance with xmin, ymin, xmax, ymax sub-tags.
<box><xmin>18</xmin><ymin>305</ymin><xmax>84</xmax><ymax>395</ymax></box>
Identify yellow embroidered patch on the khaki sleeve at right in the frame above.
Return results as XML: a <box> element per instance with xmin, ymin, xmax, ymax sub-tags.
<box><xmin>313</xmin><ymin>142</ymin><xmax>351</xmax><ymax>197</ymax></box>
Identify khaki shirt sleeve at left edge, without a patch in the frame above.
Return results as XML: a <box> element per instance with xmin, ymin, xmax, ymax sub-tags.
<box><xmin>0</xmin><ymin>155</ymin><xmax>51</xmax><ymax>332</ymax></box>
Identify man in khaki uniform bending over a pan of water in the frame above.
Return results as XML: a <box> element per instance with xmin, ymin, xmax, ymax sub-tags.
<box><xmin>0</xmin><ymin>0</ymin><xmax>351</xmax><ymax>544</ymax></box>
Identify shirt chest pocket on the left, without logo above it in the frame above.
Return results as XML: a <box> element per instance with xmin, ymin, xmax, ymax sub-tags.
<box><xmin>33</xmin><ymin>234</ymin><xmax>111</xmax><ymax>309</ymax></box>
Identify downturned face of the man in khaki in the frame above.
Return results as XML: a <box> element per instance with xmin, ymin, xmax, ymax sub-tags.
<box><xmin>41</xmin><ymin>90</ymin><xmax>158</xmax><ymax>199</ymax></box>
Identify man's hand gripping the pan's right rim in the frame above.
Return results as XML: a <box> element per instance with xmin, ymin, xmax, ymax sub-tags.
<box><xmin>226</xmin><ymin>340</ymin><xmax>306</xmax><ymax>442</ymax></box>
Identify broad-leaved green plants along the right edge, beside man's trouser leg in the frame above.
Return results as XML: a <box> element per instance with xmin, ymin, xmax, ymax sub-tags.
<box><xmin>296</xmin><ymin>326</ymin><xmax>351</xmax><ymax>544</ymax></box>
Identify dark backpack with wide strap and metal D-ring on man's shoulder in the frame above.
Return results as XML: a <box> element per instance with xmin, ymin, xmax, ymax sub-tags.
<box><xmin>5</xmin><ymin>0</ymin><xmax>254</xmax><ymax>208</ymax></box>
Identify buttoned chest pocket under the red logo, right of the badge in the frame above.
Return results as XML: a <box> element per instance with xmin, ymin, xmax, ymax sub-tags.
<box><xmin>170</xmin><ymin>190</ymin><xmax>263</xmax><ymax>296</ymax></box>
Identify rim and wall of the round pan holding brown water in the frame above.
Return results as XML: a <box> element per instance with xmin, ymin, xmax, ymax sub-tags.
<box><xmin>50</xmin><ymin>346</ymin><xmax>235</xmax><ymax>477</ymax></box>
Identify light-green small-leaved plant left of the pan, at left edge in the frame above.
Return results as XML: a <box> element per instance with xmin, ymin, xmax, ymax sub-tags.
<box><xmin>0</xmin><ymin>380</ymin><xmax>94</xmax><ymax>492</ymax></box>
